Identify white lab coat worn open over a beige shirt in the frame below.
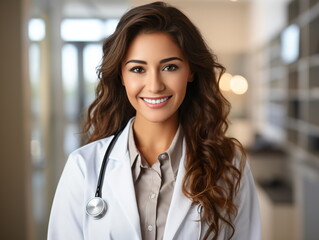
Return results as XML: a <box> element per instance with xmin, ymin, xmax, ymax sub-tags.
<box><xmin>48</xmin><ymin>120</ymin><xmax>261</xmax><ymax>240</ymax></box>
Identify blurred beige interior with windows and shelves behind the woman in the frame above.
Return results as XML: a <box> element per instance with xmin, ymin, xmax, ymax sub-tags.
<box><xmin>0</xmin><ymin>0</ymin><xmax>319</xmax><ymax>240</ymax></box>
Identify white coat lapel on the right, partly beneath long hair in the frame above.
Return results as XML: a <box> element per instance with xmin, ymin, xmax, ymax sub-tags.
<box><xmin>163</xmin><ymin>140</ymin><xmax>192</xmax><ymax>240</ymax></box>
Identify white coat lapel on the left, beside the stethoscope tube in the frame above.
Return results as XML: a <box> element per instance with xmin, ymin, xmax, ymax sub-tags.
<box><xmin>105</xmin><ymin>122</ymin><xmax>141</xmax><ymax>239</ymax></box>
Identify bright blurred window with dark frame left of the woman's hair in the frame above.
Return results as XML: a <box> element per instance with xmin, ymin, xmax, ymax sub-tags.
<box><xmin>61</xmin><ymin>19</ymin><xmax>118</xmax><ymax>155</ymax></box>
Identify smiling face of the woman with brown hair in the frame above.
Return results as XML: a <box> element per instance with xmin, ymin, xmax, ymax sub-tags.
<box><xmin>122</xmin><ymin>32</ymin><xmax>192</xmax><ymax>123</ymax></box>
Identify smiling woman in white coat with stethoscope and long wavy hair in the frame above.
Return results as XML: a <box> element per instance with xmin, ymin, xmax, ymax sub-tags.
<box><xmin>48</xmin><ymin>2</ymin><xmax>261</xmax><ymax>240</ymax></box>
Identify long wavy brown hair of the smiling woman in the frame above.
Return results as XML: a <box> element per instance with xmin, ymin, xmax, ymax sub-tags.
<box><xmin>84</xmin><ymin>2</ymin><xmax>245</xmax><ymax>239</ymax></box>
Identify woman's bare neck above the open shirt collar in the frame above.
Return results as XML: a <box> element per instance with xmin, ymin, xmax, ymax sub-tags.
<box><xmin>133</xmin><ymin>116</ymin><xmax>178</xmax><ymax>154</ymax></box>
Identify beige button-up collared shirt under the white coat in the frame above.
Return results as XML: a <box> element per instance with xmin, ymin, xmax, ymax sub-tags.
<box><xmin>128</xmin><ymin>124</ymin><xmax>183</xmax><ymax>240</ymax></box>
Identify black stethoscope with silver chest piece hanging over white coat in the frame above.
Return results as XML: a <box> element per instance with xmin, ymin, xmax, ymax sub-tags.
<box><xmin>86</xmin><ymin>130</ymin><xmax>122</xmax><ymax>219</ymax></box>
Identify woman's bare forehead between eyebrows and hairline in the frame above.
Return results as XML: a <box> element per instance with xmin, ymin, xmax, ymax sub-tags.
<box><xmin>125</xmin><ymin>32</ymin><xmax>184</xmax><ymax>60</ymax></box>
